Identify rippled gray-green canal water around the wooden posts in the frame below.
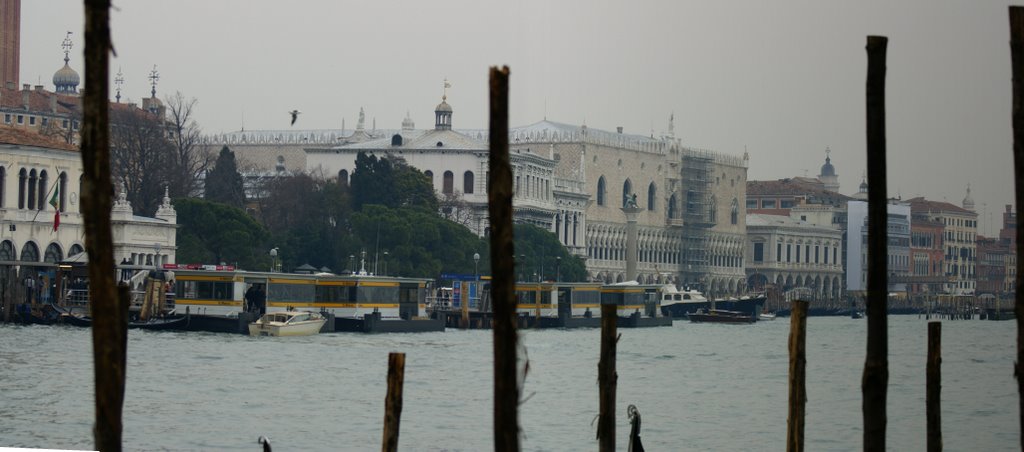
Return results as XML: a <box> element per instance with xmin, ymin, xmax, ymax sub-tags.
<box><xmin>0</xmin><ymin>317</ymin><xmax>1020</xmax><ymax>451</ymax></box>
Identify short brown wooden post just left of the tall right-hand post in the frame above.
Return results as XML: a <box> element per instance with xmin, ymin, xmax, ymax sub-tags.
<box><xmin>785</xmin><ymin>300</ymin><xmax>807</xmax><ymax>452</ymax></box>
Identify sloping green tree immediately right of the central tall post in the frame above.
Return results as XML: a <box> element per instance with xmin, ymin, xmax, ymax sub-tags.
<box><xmin>513</xmin><ymin>223</ymin><xmax>587</xmax><ymax>282</ymax></box>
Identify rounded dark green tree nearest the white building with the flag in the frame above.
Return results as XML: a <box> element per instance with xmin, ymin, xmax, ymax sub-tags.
<box><xmin>174</xmin><ymin>198</ymin><xmax>269</xmax><ymax>270</ymax></box>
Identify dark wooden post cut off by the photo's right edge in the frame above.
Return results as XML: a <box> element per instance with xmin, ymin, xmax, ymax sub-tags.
<box><xmin>1010</xmin><ymin>6</ymin><xmax>1024</xmax><ymax>449</ymax></box>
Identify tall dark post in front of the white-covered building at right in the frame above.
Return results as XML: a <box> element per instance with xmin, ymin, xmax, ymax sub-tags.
<box><xmin>860</xmin><ymin>36</ymin><xmax>889</xmax><ymax>451</ymax></box>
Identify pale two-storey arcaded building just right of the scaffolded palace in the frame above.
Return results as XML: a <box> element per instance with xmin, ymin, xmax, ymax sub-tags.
<box><xmin>745</xmin><ymin>213</ymin><xmax>843</xmax><ymax>301</ymax></box>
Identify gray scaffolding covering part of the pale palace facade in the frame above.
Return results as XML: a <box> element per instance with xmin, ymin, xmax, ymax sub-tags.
<box><xmin>679</xmin><ymin>150</ymin><xmax>715</xmax><ymax>290</ymax></box>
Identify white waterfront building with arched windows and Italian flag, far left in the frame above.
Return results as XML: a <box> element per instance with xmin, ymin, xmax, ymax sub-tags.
<box><xmin>0</xmin><ymin>126</ymin><xmax>177</xmax><ymax>277</ymax></box>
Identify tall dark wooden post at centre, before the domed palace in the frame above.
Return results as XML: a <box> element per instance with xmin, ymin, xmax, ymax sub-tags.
<box><xmin>487</xmin><ymin>66</ymin><xmax>519</xmax><ymax>451</ymax></box>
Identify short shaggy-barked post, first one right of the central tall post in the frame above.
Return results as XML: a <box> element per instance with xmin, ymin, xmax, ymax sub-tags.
<box><xmin>597</xmin><ymin>297</ymin><xmax>618</xmax><ymax>452</ymax></box>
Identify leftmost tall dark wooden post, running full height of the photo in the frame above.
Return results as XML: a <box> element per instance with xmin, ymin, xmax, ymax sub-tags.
<box><xmin>81</xmin><ymin>0</ymin><xmax>128</xmax><ymax>451</ymax></box>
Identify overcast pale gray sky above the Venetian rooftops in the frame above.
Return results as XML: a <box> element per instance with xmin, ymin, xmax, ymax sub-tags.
<box><xmin>20</xmin><ymin>0</ymin><xmax>1014</xmax><ymax>235</ymax></box>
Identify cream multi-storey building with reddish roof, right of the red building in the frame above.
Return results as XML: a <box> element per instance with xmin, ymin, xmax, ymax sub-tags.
<box><xmin>906</xmin><ymin>194</ymin><xmax>978</xmax><ymax>295</ymax></box>
